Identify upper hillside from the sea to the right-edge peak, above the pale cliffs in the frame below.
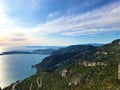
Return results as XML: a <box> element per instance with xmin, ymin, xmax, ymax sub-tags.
<box><xmin>36</xmin><ymin>39</ymin><xmax>120</xmax><ymax>71</ymax></box>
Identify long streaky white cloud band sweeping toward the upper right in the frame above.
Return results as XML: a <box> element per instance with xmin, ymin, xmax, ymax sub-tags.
<box><xmin>34</xmin><ymin>2</ymin><xmax>120</xmax><ymax>36</ymax></box>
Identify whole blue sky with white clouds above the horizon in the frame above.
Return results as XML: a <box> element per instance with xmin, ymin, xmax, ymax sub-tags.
<box><xmin>0</xmin><ymin>0</ymin><xmax>120</xmax><ymax>46</ymax></box>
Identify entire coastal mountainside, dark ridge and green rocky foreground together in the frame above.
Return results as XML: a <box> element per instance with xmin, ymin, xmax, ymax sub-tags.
<box><xmin>3</xmin><ymin>39</ymin><xmax>120</xmax><ymax>90</ymax></box>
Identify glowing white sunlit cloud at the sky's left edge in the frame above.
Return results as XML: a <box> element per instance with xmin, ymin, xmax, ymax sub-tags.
<box><xmin>0</xmin><ymin>0</ymin><xmax>36</xmax><ymax>46</ymax></box>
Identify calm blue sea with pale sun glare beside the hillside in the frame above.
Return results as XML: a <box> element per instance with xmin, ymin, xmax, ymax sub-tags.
<box><xmin>0</xmin><ymin>48</ymin><xmax>47</xmax><ymax>88</ymax></box>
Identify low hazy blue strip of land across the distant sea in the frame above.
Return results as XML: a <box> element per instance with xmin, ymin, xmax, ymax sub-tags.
<box><xmin>0</xmin><ymin>49</ymin><xmax>55</xmax><ymax>55</ymax></box>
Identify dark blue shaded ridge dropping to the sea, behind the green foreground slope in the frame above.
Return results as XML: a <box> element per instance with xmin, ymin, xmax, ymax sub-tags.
<box><xmin>36</xmin><ymin>45</ymin><xmax>97</xmax><ymax>71</ymax></box>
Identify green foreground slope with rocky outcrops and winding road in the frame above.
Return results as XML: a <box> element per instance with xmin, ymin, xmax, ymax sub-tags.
<box><xmin>3</xmin><ymin>62</ymin><xmax>120</xmax><ymax>90</ymax></box>
